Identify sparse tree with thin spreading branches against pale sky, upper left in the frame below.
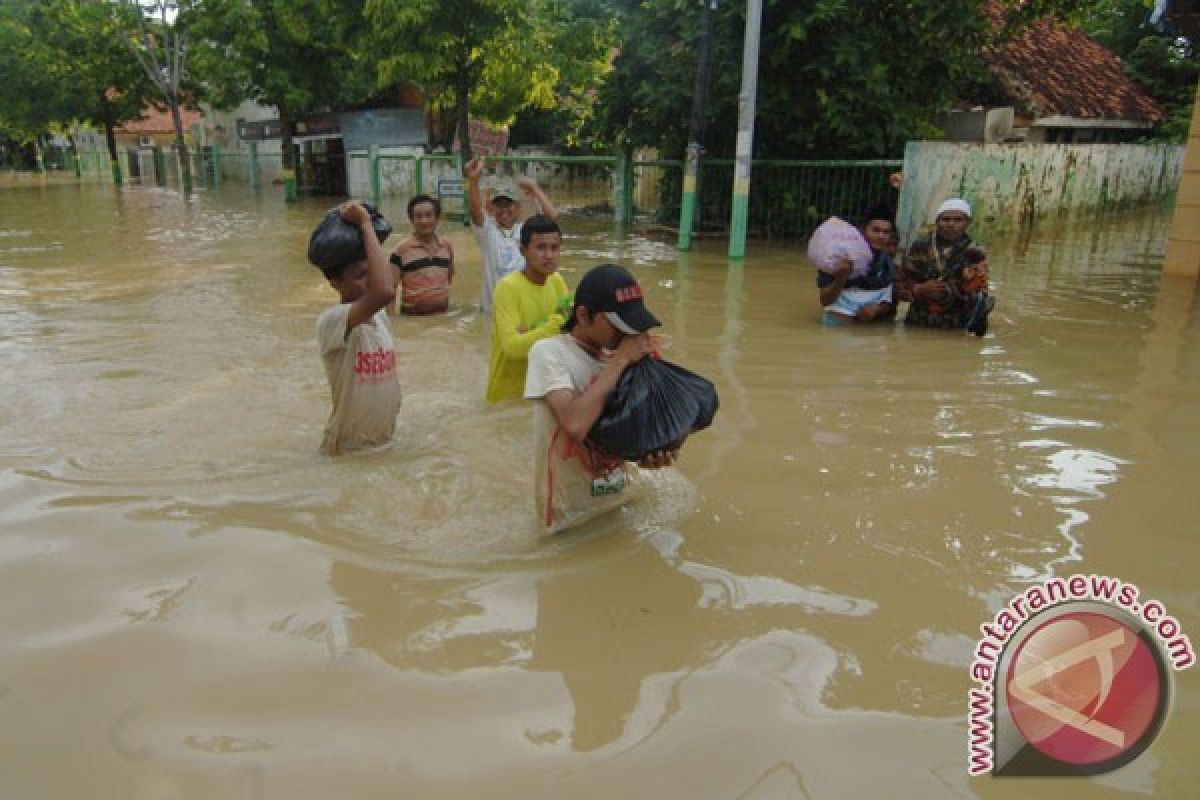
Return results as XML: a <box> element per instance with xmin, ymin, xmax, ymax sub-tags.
<box><xmin>126</xmin><ymin>0</ymin><xmax>199</xmax><ymax>193</ymax></box>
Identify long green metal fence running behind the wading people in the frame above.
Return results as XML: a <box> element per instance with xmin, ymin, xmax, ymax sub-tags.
<box><xmin>7</xmin><ymin>145</ymin><xmax>904</xmax><ymax>241</ymax></box>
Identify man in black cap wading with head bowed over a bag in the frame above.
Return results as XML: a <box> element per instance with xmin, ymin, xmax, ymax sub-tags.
<box><xmin>524</xmin><ymin>264</ymin><xmax>678</xmax><ymax>534</ymax></box>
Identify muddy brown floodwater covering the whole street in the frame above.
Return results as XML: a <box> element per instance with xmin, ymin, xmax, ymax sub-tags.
<box><xmin>0</xmin><ymin>185</ymin><xmax>1200</xmax><ymax>800</ymax></box>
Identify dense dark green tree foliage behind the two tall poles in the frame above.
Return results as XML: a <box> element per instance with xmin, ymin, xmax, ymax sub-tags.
<box><xmin>601</xmin><ymin>0</ymin><xmax>991</xmax><ymax>158</ymax></box>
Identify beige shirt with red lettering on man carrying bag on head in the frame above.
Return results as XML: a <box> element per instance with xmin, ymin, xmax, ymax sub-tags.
<box><xmin>317</xmin><ymin>302</ymin><xmax>401</xmax><ymax>456</ymax></box>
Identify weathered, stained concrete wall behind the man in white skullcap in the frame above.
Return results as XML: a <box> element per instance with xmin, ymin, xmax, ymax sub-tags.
<box><xmin>896</xmin><ymin>142</ymin><xmax>1183</xmax><ymax>242</ymax></box>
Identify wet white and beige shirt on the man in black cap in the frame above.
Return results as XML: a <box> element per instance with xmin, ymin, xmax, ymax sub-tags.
<box><xmin>524</xmin><ymin>333</ymin><xmax>637</xmax><ymax>534</ymax></box>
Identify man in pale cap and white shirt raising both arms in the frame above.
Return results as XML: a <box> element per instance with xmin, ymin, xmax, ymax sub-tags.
<box><xmin>462</xmin><ymin>157</ymin><xmax>558</xmax><ymax>314</ymax></box>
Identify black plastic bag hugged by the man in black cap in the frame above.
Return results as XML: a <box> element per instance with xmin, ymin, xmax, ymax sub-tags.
<box><xmin>588</xmin><ymin>357</ymin><xmax>718</xmax><ymax>461</ymax></box>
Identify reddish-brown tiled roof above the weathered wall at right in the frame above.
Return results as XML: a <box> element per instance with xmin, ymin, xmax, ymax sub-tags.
<box><xmin>989</xmin><ymin>18</ymin><xmax>1163</xmax><ymax>124</ymax></box>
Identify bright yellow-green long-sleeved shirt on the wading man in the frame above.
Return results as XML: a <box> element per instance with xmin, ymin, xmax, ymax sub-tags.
<box><xmin>487</xmin><ymin>271</ymin><xmax>568</xmax><ymax>403</ymax></box>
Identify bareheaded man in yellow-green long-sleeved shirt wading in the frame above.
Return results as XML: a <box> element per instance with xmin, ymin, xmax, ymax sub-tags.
<box><xmin>487</xmin><ymin>215</ymin><xmax>570</xmax><ymax>403</ymax></box>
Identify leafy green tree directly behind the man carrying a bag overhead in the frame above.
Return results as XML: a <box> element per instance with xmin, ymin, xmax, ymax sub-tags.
<box><xmin>194</xmin><ymin>0</ymin><xmax>377</xmax><ymax>175</ymax></box>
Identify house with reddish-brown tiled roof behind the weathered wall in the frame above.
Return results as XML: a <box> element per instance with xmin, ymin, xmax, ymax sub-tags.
<box><xmin>944</xmin><ymin>18</ymin><xmax>1164</xmax><ymax>144</ymax></box>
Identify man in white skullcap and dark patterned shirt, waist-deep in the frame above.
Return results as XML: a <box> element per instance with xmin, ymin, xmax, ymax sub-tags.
<box><xmin>898</xmin><ymin>197</ymin><xmax>996</xmax><ymax>336</ymax></box>
